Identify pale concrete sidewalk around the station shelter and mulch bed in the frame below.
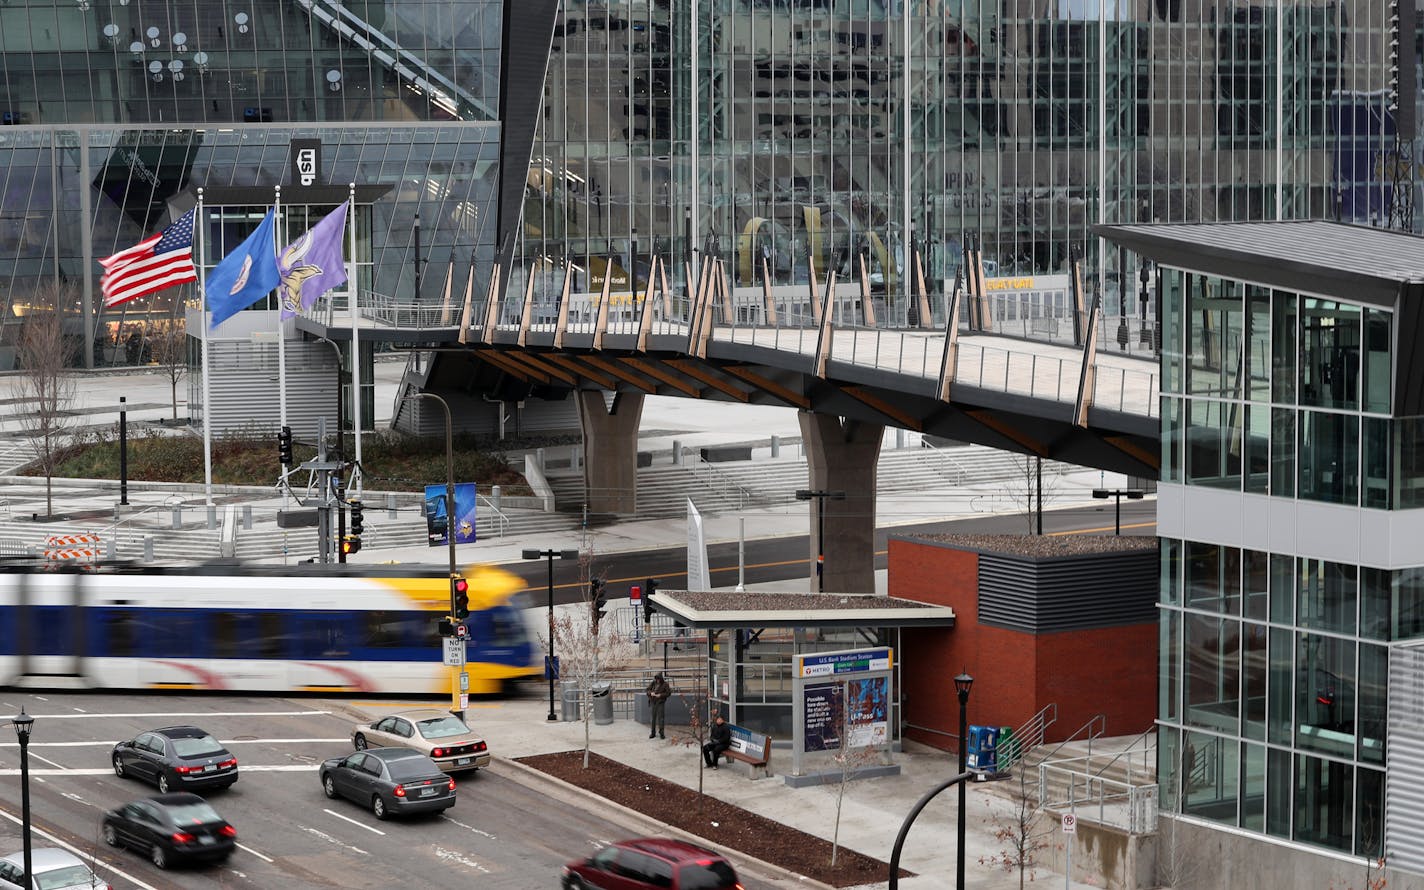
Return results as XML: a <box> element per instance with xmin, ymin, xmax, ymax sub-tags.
<box><xmin>343</xmin><ymin>699</ymin><xmax>1101</xmax><ymax>890</ymax></box>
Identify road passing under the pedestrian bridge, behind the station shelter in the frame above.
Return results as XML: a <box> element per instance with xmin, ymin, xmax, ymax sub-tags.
<box><xmin>503</xmin><ymin>501</ymin><xmax>1156</xmax><ymax>604</ymax></box>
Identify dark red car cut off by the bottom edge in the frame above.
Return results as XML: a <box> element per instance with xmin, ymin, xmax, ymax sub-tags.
<box><xmin>564</xmin><ymin>837</ymin><xmax>742</xmax><ymax>890</ymax></box>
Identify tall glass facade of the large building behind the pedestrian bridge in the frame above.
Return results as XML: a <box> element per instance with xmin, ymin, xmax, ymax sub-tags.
<box><xmin>521</xmin><ymin>0</ymin><xmax>1395</xmax><ymax>317</ymax></box>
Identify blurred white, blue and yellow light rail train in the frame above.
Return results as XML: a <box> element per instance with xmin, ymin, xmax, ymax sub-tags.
<box><xmin>0</xmin><ymin>565</ymin><xmax>543</xmax><ymax>695</ymax></box>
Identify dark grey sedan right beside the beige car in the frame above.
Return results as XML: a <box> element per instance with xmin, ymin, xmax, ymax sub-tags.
<box><xmin>322</xmin><ymin>748</ymin><xmax>454</xmax><ymax>819</ymax></box>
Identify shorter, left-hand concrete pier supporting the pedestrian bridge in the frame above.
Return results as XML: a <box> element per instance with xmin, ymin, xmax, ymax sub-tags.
<box><xmin>578</xmin><ymin>390</ymin><xmax>642</xmax><ymax>513</ymax></box>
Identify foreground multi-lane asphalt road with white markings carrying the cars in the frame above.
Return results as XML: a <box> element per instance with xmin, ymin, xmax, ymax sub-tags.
<box><xmin>0</xmin><ymin>689</ymin><xmax>770</xmax><ymax>890</ymax></box>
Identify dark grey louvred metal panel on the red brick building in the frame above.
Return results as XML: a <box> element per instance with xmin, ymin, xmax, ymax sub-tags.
<box><xmin>978</xmin><ymin>550</ymin><xmax>1158</xmax><ymax>634</ymax></box>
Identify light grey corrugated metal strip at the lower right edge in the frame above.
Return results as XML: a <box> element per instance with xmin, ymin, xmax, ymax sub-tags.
<box><xmin>1384</xmin><ymin>644</ymin><xmax>1424</xmax><ymax>873</ymax></box>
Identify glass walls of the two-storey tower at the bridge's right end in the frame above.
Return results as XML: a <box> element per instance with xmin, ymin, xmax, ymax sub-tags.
<box><xmin>1158</xmin><ymin>262</ymin><xmax>1401</xmax><ymax>857</ymax></box>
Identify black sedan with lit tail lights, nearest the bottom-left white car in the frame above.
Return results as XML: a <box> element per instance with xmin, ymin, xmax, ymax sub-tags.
<box><xmin>104</xmin><ymin>792</ymin><xmax>238</xmax><ymax>869</ymax></box>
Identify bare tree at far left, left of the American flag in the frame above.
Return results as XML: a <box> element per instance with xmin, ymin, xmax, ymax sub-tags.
<box><xmin>16</xmin><ymin>299</ymin><xmax>74</xmax><ymax>517</ymax></box>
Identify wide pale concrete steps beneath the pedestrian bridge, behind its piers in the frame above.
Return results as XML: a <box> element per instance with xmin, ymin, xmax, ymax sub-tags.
<box><xmin>548</xmin><ymin>443</ymin><xmax>1068</xmax><ymax>520</ymax></box>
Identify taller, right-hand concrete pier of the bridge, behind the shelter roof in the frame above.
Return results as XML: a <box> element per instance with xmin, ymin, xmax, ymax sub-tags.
<box><xmin>797</xmin><ymin>412</ymin><xmax>884</xmax><ymax>594</ymax></box>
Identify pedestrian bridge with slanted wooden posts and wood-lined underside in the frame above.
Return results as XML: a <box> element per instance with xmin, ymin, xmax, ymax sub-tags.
<box><xmin>299</xmin><ymin>270</ymin><xmax>1159</xmax><ymax>478</ymax></box>
